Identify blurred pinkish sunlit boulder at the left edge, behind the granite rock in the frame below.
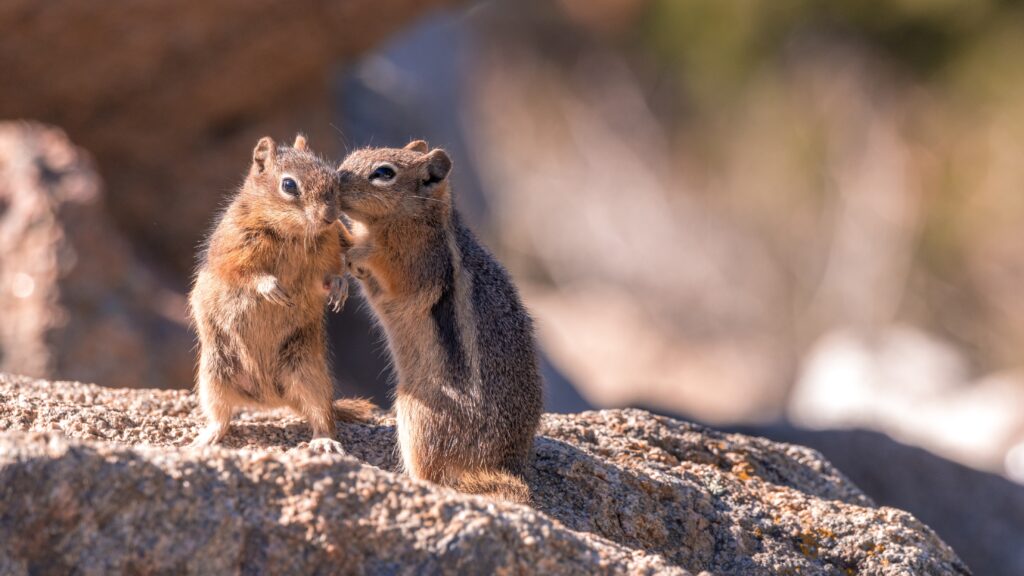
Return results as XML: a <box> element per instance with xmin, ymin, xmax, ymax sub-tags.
<box><xmin>0</xmin><ymin>123</ymin><xmax>193</xmax><ymax>387</ymax></box>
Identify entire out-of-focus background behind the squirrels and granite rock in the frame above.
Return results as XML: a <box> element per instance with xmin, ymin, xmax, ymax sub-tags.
<box><xmin>0</xmin><ymin>0</ymin><xmax>1024</xmax><ymax>575</ymax></box>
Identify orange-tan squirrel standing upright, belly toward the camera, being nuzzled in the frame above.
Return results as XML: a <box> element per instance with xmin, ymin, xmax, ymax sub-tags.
<box><xmin>188</xmin><ymin>134</ymin><xmax>374</xmax><ymax>452</ymax></box>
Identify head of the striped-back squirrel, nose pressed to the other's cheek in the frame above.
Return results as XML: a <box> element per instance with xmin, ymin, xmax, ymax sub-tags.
<box><xmin>338</xmin><ymin>140</ymin><xmax>452</xmax><ymax>220</ymax></box>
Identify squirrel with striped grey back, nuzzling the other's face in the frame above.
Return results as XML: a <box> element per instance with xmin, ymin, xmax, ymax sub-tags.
<box><xmin>338</xmin><ymin>140</ymin><xmax>542</xmax><ymax>503</ymax></box>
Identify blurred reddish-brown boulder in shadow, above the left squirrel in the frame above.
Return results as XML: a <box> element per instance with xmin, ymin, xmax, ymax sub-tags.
<box><xmin>0</xmin><ymin>0</ymin><xmax>464</xmax><ymax>276</ymax></box>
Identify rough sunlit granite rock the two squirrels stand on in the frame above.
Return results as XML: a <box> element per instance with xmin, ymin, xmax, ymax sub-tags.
<box><xmin>0</xmin><ymin>376</ymin><xmax>970</xmax><ymax>575</ymax></box>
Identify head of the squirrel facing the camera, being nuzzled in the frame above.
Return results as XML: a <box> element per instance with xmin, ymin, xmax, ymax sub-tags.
<box><xmin>246</xmin><ymin>134</ymin><xmax>338</xmax><ymax>235</ymax></box>
